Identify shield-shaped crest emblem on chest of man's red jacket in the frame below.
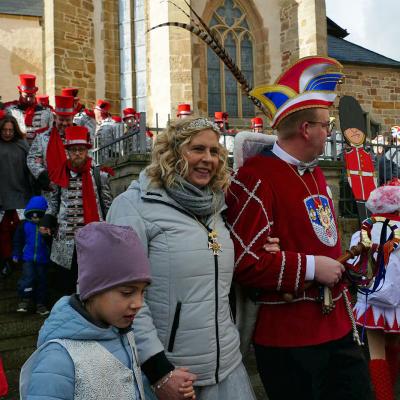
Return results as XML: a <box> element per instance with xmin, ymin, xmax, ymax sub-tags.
<box><xmin>304</xmin><ymin>195</ymin><xmax>337</xmax><ymax>247</ymax></box>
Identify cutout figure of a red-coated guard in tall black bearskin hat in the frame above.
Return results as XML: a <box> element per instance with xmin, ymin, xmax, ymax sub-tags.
<box><xmin>339</xmin><ymin>96</ymin><xmax>377</xmax><ymax>202</ymax></box>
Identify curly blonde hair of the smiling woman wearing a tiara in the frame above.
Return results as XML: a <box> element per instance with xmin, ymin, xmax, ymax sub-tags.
<box><xmin>146</xmin><ymin>117</ymin><xmax>229</xmax><ymax>191</ymax></box>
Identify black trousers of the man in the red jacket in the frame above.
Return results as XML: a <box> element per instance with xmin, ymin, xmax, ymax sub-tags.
<box><xmin>254</xmin><ymin>334</ymin><xmax>372</xmax><ymax>400</ymax></box>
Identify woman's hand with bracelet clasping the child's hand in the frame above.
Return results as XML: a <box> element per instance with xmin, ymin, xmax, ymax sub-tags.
<box><xmin>154</xmin><ymin>368</ymin><xmax>196</xmax><ymax>400</ymax></box>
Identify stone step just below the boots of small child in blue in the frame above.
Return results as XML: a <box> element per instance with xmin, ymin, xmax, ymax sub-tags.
<box><xmin>0</xmin><ymin>312</ymin><xmax>45</xmax><ymax>341</ymax></box>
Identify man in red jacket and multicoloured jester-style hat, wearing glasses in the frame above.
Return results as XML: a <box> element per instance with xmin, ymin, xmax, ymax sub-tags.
<box><xmin>227</xmin><ymin>57</ymin><xmax>370</xmax><ymax>400</ymax></box>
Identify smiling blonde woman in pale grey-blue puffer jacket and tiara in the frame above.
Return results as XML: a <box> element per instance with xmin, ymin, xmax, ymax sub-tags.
<box><xmin>107</xmin><ymin>118</ymin><xmax>254</xmax><ymax>400</ymax></box>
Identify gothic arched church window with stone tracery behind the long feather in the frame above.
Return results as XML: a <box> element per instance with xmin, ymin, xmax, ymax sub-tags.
<box><xmin>207</xmin><ymin>0</ymin><xmax>254</xmax><ymax>118</ymax></box>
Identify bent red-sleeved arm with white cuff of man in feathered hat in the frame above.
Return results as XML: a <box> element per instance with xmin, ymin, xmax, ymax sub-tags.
<box><xmin>227</xmin><ymin>168</ymin><xmax>344</xmax><ymax>293</ymax></box>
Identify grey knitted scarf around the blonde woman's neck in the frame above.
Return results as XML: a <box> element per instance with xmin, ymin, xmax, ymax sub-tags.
<box><xmin>165</xmin><ymin>175</ymin><xmax>225</xmax><ymax>218</ymax></box>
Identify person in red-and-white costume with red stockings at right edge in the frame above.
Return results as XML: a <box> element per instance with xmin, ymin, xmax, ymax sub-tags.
<box><xmin>351</xmin><ymin>179</ymin><xmax>400</xmax><ymax>400</ymax></box>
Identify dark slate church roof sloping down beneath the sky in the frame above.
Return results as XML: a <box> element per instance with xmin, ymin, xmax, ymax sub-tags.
<box><xmin>327</xmin><ymin>18</ymin><xmax>400</xmax><ymax>68</ymax></box>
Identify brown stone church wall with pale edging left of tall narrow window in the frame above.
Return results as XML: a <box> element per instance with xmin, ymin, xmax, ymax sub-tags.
<box><xmin>45</xmin><ymin>0</ymin><xmax>120</xmax><ymax>112</ymax></box>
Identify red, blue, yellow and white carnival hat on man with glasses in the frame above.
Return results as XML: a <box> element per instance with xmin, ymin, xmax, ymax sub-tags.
<box><xmin>250</xmin><ymin>56</ymin><xmax>343</xmax><ymax>128</ymax></box>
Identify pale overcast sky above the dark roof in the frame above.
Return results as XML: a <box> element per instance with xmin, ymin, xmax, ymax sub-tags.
<box><xmin>326</xmin><ymin>0</ymin><xmax>400</xmax><ymax>61</ymax></box>
